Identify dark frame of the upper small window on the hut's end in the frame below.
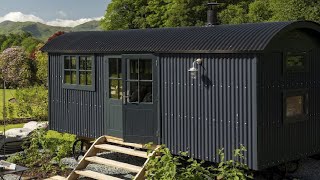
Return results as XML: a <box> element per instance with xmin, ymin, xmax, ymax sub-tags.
<box><xmin>282</xmin><ymin>50</ymin><xmax>309</xmax><ymax>73</ymax></box>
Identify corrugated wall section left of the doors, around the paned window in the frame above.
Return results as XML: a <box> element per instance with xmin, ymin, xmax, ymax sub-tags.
<box><xmin>49</xmin><ymin>54</ymin><xmax>106</xmax><ymax>138</ymax></box>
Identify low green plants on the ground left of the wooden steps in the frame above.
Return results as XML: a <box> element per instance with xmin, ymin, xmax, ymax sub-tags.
<box><xmin>7</xmin><ymin>129</ymin><xmax>75</xmax><ymax>176</ymax></box>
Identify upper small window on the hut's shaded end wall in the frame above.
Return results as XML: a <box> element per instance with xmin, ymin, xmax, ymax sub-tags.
<box><xmin>285</xmin><ymin>52</ymin><xmax>306</xmax><ymax>72</ymax></box>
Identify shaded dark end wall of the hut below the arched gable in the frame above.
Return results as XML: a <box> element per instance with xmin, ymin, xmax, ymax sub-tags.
<box><xmin>258</xmin><ymin>49</ymin><xmax>320</xmax><ymax>168</ymax></box>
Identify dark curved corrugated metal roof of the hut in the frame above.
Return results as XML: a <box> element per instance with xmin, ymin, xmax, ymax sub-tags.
<box><xmin>42</xmin><ymin>21</ymin><xmax>320</xmax><ymax>53</ymax></box>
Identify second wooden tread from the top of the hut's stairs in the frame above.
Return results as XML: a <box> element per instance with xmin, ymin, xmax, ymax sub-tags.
<box><xmin>94</xmin><ymin>144</ymin><xmax>148</xmax><ymax>158</ymax></box>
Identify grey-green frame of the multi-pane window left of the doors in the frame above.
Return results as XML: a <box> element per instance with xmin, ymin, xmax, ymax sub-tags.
<box><xmin>61</xmin><ymin>54</ymin><xmax>96</xmax><ymax>91</ymax></box>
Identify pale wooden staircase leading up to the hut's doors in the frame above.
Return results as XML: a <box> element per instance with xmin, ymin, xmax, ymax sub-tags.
<box><xmin>48</xmin><ymin>136</ymin><xmax>156</xmax><ymax>180</ymax></box>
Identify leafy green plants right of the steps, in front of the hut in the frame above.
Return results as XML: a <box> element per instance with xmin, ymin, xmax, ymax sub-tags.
<box><xmin>146</xmin><ymin>145</ymin><xmax>253</xmax><ymax>180</ymax></box>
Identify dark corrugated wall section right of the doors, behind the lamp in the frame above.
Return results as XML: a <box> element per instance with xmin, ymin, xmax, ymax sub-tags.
<box><xmin>159</xmin><ymin>54</ymin><xmax>257</xmax><ymax>169</ymax></box>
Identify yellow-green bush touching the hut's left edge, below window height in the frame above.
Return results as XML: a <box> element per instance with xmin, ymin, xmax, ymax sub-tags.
<box><xmin>8</xmin><ymin>86</ymin><xmax>48</xmax><ymax>120</ymax></box>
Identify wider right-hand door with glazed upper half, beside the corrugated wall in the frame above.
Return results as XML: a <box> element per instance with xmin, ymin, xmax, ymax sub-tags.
<box><xmin>122</xmin><ymin>55</ymin><xmax>158</xmax><ymax>143</ymax></box>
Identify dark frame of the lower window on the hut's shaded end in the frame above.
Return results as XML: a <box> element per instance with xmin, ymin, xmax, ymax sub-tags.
<box><xmin>282</xmin><ymin>89</ymin><xmax>309</xmax><ymax>124</ymax></box>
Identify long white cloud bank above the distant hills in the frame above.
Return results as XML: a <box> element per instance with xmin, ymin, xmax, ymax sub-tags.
<box><xmin>0</xmin><ymin>11</ymin><xmax>102</xmax><ymax>27</ymax></box>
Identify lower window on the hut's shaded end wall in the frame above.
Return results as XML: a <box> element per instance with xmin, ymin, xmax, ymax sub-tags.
<box><xmin>284</xmin><ymin>91</ymin><xmax>308</xmax><ymax>123</ymax></box>
